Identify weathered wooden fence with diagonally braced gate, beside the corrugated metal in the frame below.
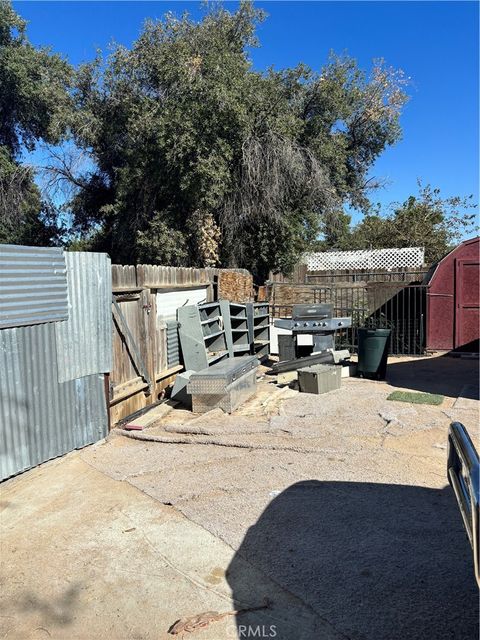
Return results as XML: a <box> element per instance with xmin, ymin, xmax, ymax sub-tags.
<box><xmin>109</xmin><ymin>265</ymin><xmax>253</xmax><ymax>424</ymax></box>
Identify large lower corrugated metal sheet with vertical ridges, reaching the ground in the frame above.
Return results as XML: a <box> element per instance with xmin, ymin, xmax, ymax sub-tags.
<box><xmin>0</xmin><ymin>323</ymin><xmax>108</xmax><ymax>480</ymax></box>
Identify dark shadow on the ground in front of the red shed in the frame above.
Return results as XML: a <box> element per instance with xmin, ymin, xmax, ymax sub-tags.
<box><xmin>387</xmin><ymin>355</ymin><xmax>479</xmax><ymax>400</ymax></box>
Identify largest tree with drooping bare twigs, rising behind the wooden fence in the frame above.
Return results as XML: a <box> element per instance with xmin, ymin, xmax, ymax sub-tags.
<box><xmin>63</xmin><ymin>3</ymin><xmax>406</xmax><ymax>279</ymax></box>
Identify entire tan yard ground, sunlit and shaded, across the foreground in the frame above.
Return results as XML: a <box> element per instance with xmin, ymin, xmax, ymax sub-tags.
<box><xmin>0</xmin><ymin>357</ymin><xmax>478</xmax><ymax>640</ymax></box>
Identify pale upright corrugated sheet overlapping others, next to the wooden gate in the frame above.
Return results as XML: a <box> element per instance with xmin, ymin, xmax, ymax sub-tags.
<box><xmin>55</xmin><ymin>252</ymin><xmax>112</xmax><ymax>382</ymax></box>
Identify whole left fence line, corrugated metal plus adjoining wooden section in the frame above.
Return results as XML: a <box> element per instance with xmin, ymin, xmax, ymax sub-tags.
<box><xmin>0</xmin><ymin>250</ymin><xmax>253</xmax><ymax>479</ymax></box>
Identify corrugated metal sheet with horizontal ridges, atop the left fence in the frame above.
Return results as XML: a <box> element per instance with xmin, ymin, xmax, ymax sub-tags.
<box><xmin>0</xmin><ymin>244</ymin><xmax>68</xmax><ymax>329</ymax></box>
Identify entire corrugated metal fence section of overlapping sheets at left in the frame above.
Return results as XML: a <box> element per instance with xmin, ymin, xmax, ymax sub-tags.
<box><xmin>0</xmin><ymin>245</ymin><xmax>112</xmax><ymax>479</ymax></box>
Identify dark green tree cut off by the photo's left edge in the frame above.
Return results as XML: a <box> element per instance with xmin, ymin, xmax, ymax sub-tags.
<box><xmin>0</xmin><ymin>0</ymin><xmax>70</xmax><ymax>244</ymax></box>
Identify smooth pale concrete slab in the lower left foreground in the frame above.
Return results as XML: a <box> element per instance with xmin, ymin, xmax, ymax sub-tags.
<box><xmin>0</xmin><ymin>452</ymin><xmax>330</xmax><ymax>640</ymax></box>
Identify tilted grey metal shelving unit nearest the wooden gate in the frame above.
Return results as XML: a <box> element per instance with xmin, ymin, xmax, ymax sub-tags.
<box><xmin>177</xmin><ymin>301</ymin><xmax>230</xmax><ymax>371</ymax></box>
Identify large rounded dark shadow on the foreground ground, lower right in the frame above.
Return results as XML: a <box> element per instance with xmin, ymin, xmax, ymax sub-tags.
<box><xmin>227</xmin><ymin>481</ymin><xmax>478</xmax><ymax>640</ymax></box>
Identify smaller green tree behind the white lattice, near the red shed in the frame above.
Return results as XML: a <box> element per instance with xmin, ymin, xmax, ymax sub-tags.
<box><xmin>349</xmin><ymin>182</ymin><xmax>476</xmax><ymax>264</ymax></box>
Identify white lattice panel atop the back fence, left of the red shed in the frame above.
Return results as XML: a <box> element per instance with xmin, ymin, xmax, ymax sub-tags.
<box><xmin>305</xmin><ymin>247</ymin><xmax>425</xmax><ymax>271</ymax></box>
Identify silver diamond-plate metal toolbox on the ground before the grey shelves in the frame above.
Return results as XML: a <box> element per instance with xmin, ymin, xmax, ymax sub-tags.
<box><xmin>187</xmin><ymin>356</ymin><xmax>259</xmax><ymax>413</ymax></box>
